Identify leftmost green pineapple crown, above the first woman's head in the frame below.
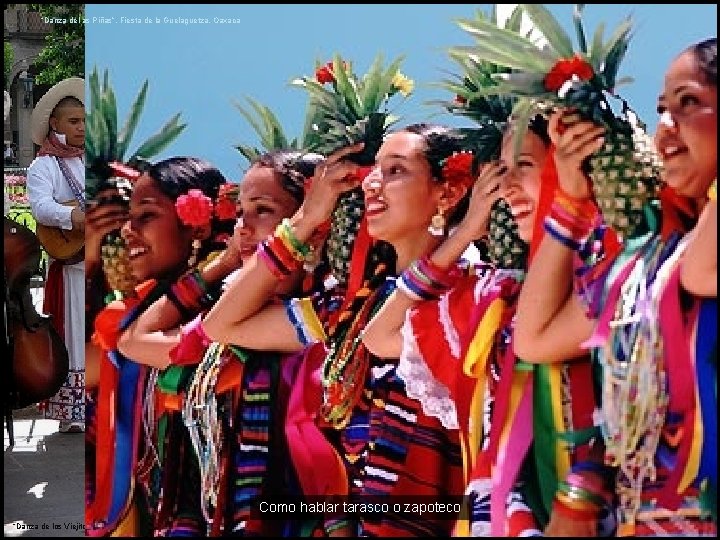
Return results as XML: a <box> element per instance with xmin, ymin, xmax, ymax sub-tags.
<box><xmin>85</xmin><ymin>67</ymin><xmax>186</xmax><ymax>198</ymax></box>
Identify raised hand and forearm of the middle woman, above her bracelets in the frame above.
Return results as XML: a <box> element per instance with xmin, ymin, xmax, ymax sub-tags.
<box><xmin>296</xmin><ymin>143</ymin><xmax>364</xmax><ymax>227</ymax></box>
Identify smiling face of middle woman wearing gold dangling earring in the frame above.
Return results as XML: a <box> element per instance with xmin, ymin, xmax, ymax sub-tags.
<box><xmin>362</xmin><ymin>131</ymin><xmax>442</xmax><ymax>245</ymax></box>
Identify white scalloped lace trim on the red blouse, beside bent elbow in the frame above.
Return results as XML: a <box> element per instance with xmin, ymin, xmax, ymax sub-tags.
<box><xmin>396</xmin><ymin>310</ymin><xmax>459</xmax><ymax>429</ymax></box>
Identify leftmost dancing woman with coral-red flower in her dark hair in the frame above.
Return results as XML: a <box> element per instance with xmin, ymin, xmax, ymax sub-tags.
<box><xmin>86</xmin><ymin>157</ymin><xmax>234</xmax><ymax>536</ymax></box>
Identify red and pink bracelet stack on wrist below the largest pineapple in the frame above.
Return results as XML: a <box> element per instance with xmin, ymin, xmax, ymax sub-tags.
<box><xmin>544</xmin><ymin>188</ymin><xmax>598</xmax><ymax>251</ymax></box>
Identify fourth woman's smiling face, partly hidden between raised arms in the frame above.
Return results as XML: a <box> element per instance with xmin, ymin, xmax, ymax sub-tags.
<box><xmin>500</xmin><ymin>130</ymin><xmax>547</xmax><ymax>243</ymax></box>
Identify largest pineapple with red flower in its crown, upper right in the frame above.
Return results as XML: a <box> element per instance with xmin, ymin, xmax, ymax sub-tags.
<box><xmin>451</xmin><ymin>4</ymin><xmax>660</xmax><ymax>238</ymax></box>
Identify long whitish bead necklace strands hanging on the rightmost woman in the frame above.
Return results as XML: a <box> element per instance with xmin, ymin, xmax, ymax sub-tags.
<box><xmin>602</xmin><ymin>230</ymin><xmax>687</xmax><ymax>523</ymax></box>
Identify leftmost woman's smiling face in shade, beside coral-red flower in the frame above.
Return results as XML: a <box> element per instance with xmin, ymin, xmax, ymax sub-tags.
<box><xmin>122</xmin><ymin>175</ymin><xmax>193</xmax><ymax>281</ymax></box>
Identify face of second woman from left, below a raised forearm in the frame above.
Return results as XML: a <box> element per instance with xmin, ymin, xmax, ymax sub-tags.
<box><xmin>233</xmin><ymin>165</ymin><xmax>300</xmax><ymax>263</ymax></box>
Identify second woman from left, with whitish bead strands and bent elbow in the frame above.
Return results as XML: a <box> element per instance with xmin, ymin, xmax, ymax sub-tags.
<box><xmin>118</xmin><ymin>150</ymin><xmax>321</xmax><ymax>534</ymax></box>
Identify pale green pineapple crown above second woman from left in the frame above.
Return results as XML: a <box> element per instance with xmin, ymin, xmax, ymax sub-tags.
<box><xmin>233</xmin><ymin>97</ymin><xmax>320</xmax><ymax>163</ymax></box>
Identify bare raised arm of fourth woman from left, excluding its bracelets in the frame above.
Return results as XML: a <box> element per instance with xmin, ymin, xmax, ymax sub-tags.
<box><xmin>363</xmin><ymin>163</ymin><xmax>502</xmax><ymax>358</ymax></box>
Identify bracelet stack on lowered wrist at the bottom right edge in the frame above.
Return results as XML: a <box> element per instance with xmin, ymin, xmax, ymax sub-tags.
<box><xmin>553</xmin><ymin>471</ymin><xmax>611</xmax><ymax>521</ymax></box>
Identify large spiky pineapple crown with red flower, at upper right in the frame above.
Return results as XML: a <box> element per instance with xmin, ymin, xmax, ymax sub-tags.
<box><xmin>450</xmin><ymin>4</ymin><xmax>632</xmax><ymax>129</ymax></box>
